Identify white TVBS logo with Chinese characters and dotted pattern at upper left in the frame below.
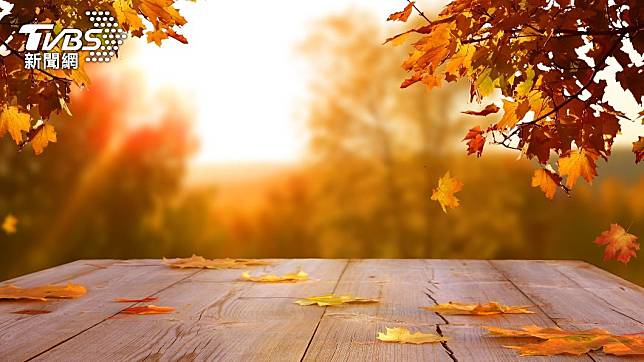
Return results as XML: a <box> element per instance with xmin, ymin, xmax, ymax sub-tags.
<box><xmin>18</xmin><ymin>11</ymin><xmax>127</xmax><ymax>69</ymax></box>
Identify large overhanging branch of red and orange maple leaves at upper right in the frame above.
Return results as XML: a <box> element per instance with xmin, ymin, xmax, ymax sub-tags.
<box><xmin>387</xmin><ymin>0</ymin><xmax>644</xmax><ymax>198</ymax></box>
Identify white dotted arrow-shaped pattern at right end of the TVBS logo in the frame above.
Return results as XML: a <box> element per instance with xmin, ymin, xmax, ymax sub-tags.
<box><xmin>85</xmin><ymin>10</ymin><xmax>127</xmax><ymax>63</ymax></box>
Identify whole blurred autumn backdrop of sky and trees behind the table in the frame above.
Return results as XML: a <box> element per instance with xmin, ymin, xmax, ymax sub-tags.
<box><xmin>0</xmin><ymin>0</ymin><xmax>644</xmax><ymax>285</ymax></box>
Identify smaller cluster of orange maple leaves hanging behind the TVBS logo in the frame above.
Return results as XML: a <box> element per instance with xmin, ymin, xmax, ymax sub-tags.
<box><xmin>0</xmin><ymin>0</ymin><xmax>187</xmax><ymax>155</ymax></box>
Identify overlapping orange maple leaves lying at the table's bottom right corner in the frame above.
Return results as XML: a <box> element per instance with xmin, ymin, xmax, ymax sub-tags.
<box><xmin>483</xmin><ymin>326</ymin><xmax>644</xmax><ymax>356</ymax></box>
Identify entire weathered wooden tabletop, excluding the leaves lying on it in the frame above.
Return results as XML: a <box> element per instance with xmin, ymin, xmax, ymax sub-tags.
<box><xmin>0</xmin><ymin>259</ymin><xmax>644</xmax><ymax>361</ymax></box>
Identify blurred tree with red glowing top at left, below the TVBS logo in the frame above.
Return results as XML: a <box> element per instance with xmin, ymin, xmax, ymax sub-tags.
<box><xmin>0</xmin><ymin>71</ymin><xmax>194</xmax><ymax>276</ymax></box>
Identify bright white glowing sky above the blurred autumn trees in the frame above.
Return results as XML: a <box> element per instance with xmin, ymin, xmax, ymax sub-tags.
<box><xmin>120</xmin><ymin>0</ymin><xmax>642</xmax><ymax>164</ymax></box>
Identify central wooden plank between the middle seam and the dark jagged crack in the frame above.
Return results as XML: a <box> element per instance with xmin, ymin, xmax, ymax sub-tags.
<box><xmin>304</xmin><ymin>260</ymin><xmax>452</xmax><ymax>361</ymax></box>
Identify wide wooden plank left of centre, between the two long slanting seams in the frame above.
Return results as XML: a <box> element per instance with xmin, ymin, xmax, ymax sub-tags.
<box><xmin>31</xmin><ymin>259</ymin><xmax>347</xmax><ymax>361</ymax></box>
